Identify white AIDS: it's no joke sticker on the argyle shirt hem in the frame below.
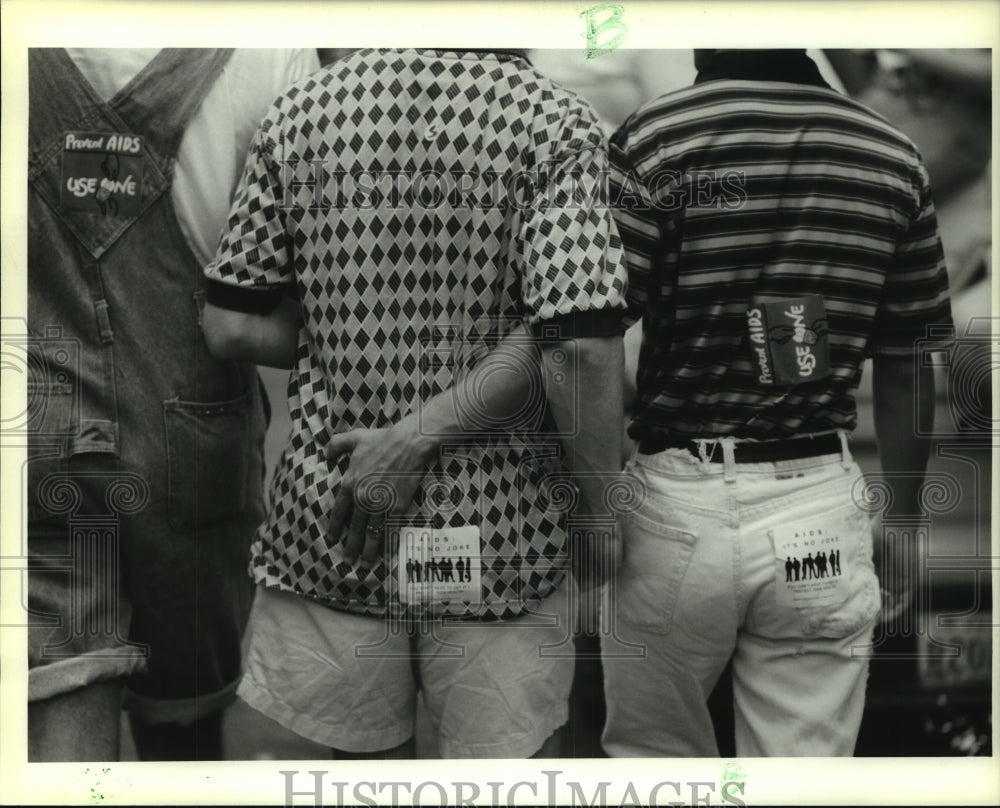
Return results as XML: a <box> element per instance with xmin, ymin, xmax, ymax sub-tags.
<box><xmin>397</xmin><ymin>525</ymin><xmax>481</xmax><ymax>604</ymax></box>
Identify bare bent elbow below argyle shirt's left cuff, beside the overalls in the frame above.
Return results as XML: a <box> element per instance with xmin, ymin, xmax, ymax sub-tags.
<box><xmin>202</xmin><ymin>297</ymin><xmax>302</xmax><ymax>369</ymax></box>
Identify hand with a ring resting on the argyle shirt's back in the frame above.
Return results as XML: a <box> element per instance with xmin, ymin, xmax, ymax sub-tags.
<box><xmin>325</xmin><ymin>414</ymin><xmax>434</xmax><ymax>565</ymax></box>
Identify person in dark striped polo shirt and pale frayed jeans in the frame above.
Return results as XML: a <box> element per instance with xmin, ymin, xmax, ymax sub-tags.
<box><xmin>604</xmin><ymin>50</ymin><xmax>951</xmax><ymax>757</ymax></box>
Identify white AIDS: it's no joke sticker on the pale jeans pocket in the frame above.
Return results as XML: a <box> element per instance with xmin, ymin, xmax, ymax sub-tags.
<box><xmin>771</xmin><ymin>519</ymin><xmax>849</xmax><ymax>607</ymax></box>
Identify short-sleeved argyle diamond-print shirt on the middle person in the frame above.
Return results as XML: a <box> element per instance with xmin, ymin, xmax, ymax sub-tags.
<box><xmin>206</xmin><ymin>50</ymin><xmax>626</xmax><ymax>619</ymax></box>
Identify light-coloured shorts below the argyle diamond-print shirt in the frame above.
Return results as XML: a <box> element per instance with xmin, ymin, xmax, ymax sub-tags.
<box><xmin>238</xmin><ymin>580</ymin><xmax>574</xmax><ymax>758</ymax></box>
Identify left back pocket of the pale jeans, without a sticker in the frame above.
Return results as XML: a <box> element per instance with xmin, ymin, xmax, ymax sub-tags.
<box><xmin>615</xmin><ymin>513</ymin><xmax>696</xmax><ymax>634</ymax></box>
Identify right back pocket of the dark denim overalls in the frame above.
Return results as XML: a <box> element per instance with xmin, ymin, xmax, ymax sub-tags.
<box><xmin>163</xmin><ymin>392</ymin><xmax>252</xmax><ymax>530</ymax></box>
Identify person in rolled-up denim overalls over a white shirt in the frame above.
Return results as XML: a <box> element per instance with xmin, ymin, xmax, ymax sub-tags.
<box><xmin>27</xmin><ymin>48</ymin><xmax>318</xmax><ymax>761</ymax></box>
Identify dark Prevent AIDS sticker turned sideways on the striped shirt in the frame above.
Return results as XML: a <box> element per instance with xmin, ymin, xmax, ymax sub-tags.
<box><xmin>747</xmin><ymin>295</ymin><xmax>830</xmax><ymax>386</ymax></box>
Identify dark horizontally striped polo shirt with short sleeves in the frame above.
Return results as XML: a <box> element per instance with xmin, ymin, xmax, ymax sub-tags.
<box><xmin>611</xmin><ymin>52</ymin><xmax>951</xmax><ymax>440</ymax></box>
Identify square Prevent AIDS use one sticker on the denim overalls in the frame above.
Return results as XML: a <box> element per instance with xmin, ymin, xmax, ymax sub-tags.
<box><xmin>59</xmin><ymin>132</ymin><xmax>143</xmax><ymax>217</ymax></box>
